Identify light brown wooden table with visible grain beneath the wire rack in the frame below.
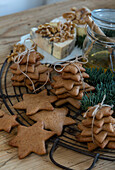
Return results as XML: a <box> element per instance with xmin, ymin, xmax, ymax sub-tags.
<box><xmin>0</xmin><ymin>0</ymin><xmax>115</xmax><ymax>170</ymax></box>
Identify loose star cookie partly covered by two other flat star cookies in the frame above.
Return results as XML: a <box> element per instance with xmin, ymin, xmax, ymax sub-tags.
<box><xmin>30</xmin><ymin>108</ymin><xmax>75</xmax><ymax>135</ymax></box>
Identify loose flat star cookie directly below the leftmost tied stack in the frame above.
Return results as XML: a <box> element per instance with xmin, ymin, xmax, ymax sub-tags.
<box><xmin>13</xmin><ymin>89</ymin><xmax>57</xmax><ymax>115</ymax></box>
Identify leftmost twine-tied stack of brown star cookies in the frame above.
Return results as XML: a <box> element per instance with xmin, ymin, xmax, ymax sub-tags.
<box><xmin>10</xmin><ymin>51</ymin><xmax>52</xmax><ymax>90</ymax></box>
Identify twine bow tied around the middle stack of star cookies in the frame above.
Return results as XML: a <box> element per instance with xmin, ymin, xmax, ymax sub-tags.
<box><xmin>54</xmin><ymin>56</ymin><xmax>88</xmax><ymax>91</ymax></box>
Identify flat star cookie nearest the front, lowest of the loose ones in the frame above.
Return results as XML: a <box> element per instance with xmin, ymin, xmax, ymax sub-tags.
<box><xmin>9</xmin><ymin>122</ymin><xmax>55</xmax><ymax>159</ymax></box>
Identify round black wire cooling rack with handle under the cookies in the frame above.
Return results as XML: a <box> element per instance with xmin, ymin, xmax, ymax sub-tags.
<box><xmin>0</xmin><ymin>59</ymin><xmax>115</xmax><ymax>170</ymax></box>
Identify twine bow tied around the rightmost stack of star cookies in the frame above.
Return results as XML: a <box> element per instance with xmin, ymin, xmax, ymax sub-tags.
<box><xmin>84</xmin><ymin>95</ymin><xmax>113</xmax><ymax>143</ymax></box>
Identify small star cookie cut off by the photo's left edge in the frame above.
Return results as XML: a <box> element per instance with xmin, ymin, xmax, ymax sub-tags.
<box><xmin>0</xmin><ymin>110</ymin><xmax>19</xmax><ymax>132</ymax></box>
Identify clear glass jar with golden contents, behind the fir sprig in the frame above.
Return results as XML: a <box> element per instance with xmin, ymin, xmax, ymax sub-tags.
<box><xmin>83</xmin><ymin>9</ymin><xmax>115</xmax><ymax>72</ymax></box>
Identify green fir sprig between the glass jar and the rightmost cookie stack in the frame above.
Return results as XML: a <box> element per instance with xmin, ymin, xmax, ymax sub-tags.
<box><xmin>81</xmin><ymin>68</ymin><xmax>115</xmax><ymax>115</ymax></box>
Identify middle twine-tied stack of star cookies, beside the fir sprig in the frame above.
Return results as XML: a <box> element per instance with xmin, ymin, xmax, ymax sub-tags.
<box><xmin>51</xmin><ymin>62</ymin><xmax>95</xmax><ymax>109</ymax></box>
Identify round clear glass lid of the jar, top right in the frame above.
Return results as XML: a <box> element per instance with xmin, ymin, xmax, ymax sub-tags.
<box><xmin>91</xmin><ymin>9</ymin><xmax>115</xmax><ymax>30</ymax></box>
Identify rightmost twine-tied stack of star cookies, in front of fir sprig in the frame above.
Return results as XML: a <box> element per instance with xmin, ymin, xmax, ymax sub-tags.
<box><xmin>76</xmin><ymin>106</ymin><xmax>115</xmax><ymax>151</ymax></box>
